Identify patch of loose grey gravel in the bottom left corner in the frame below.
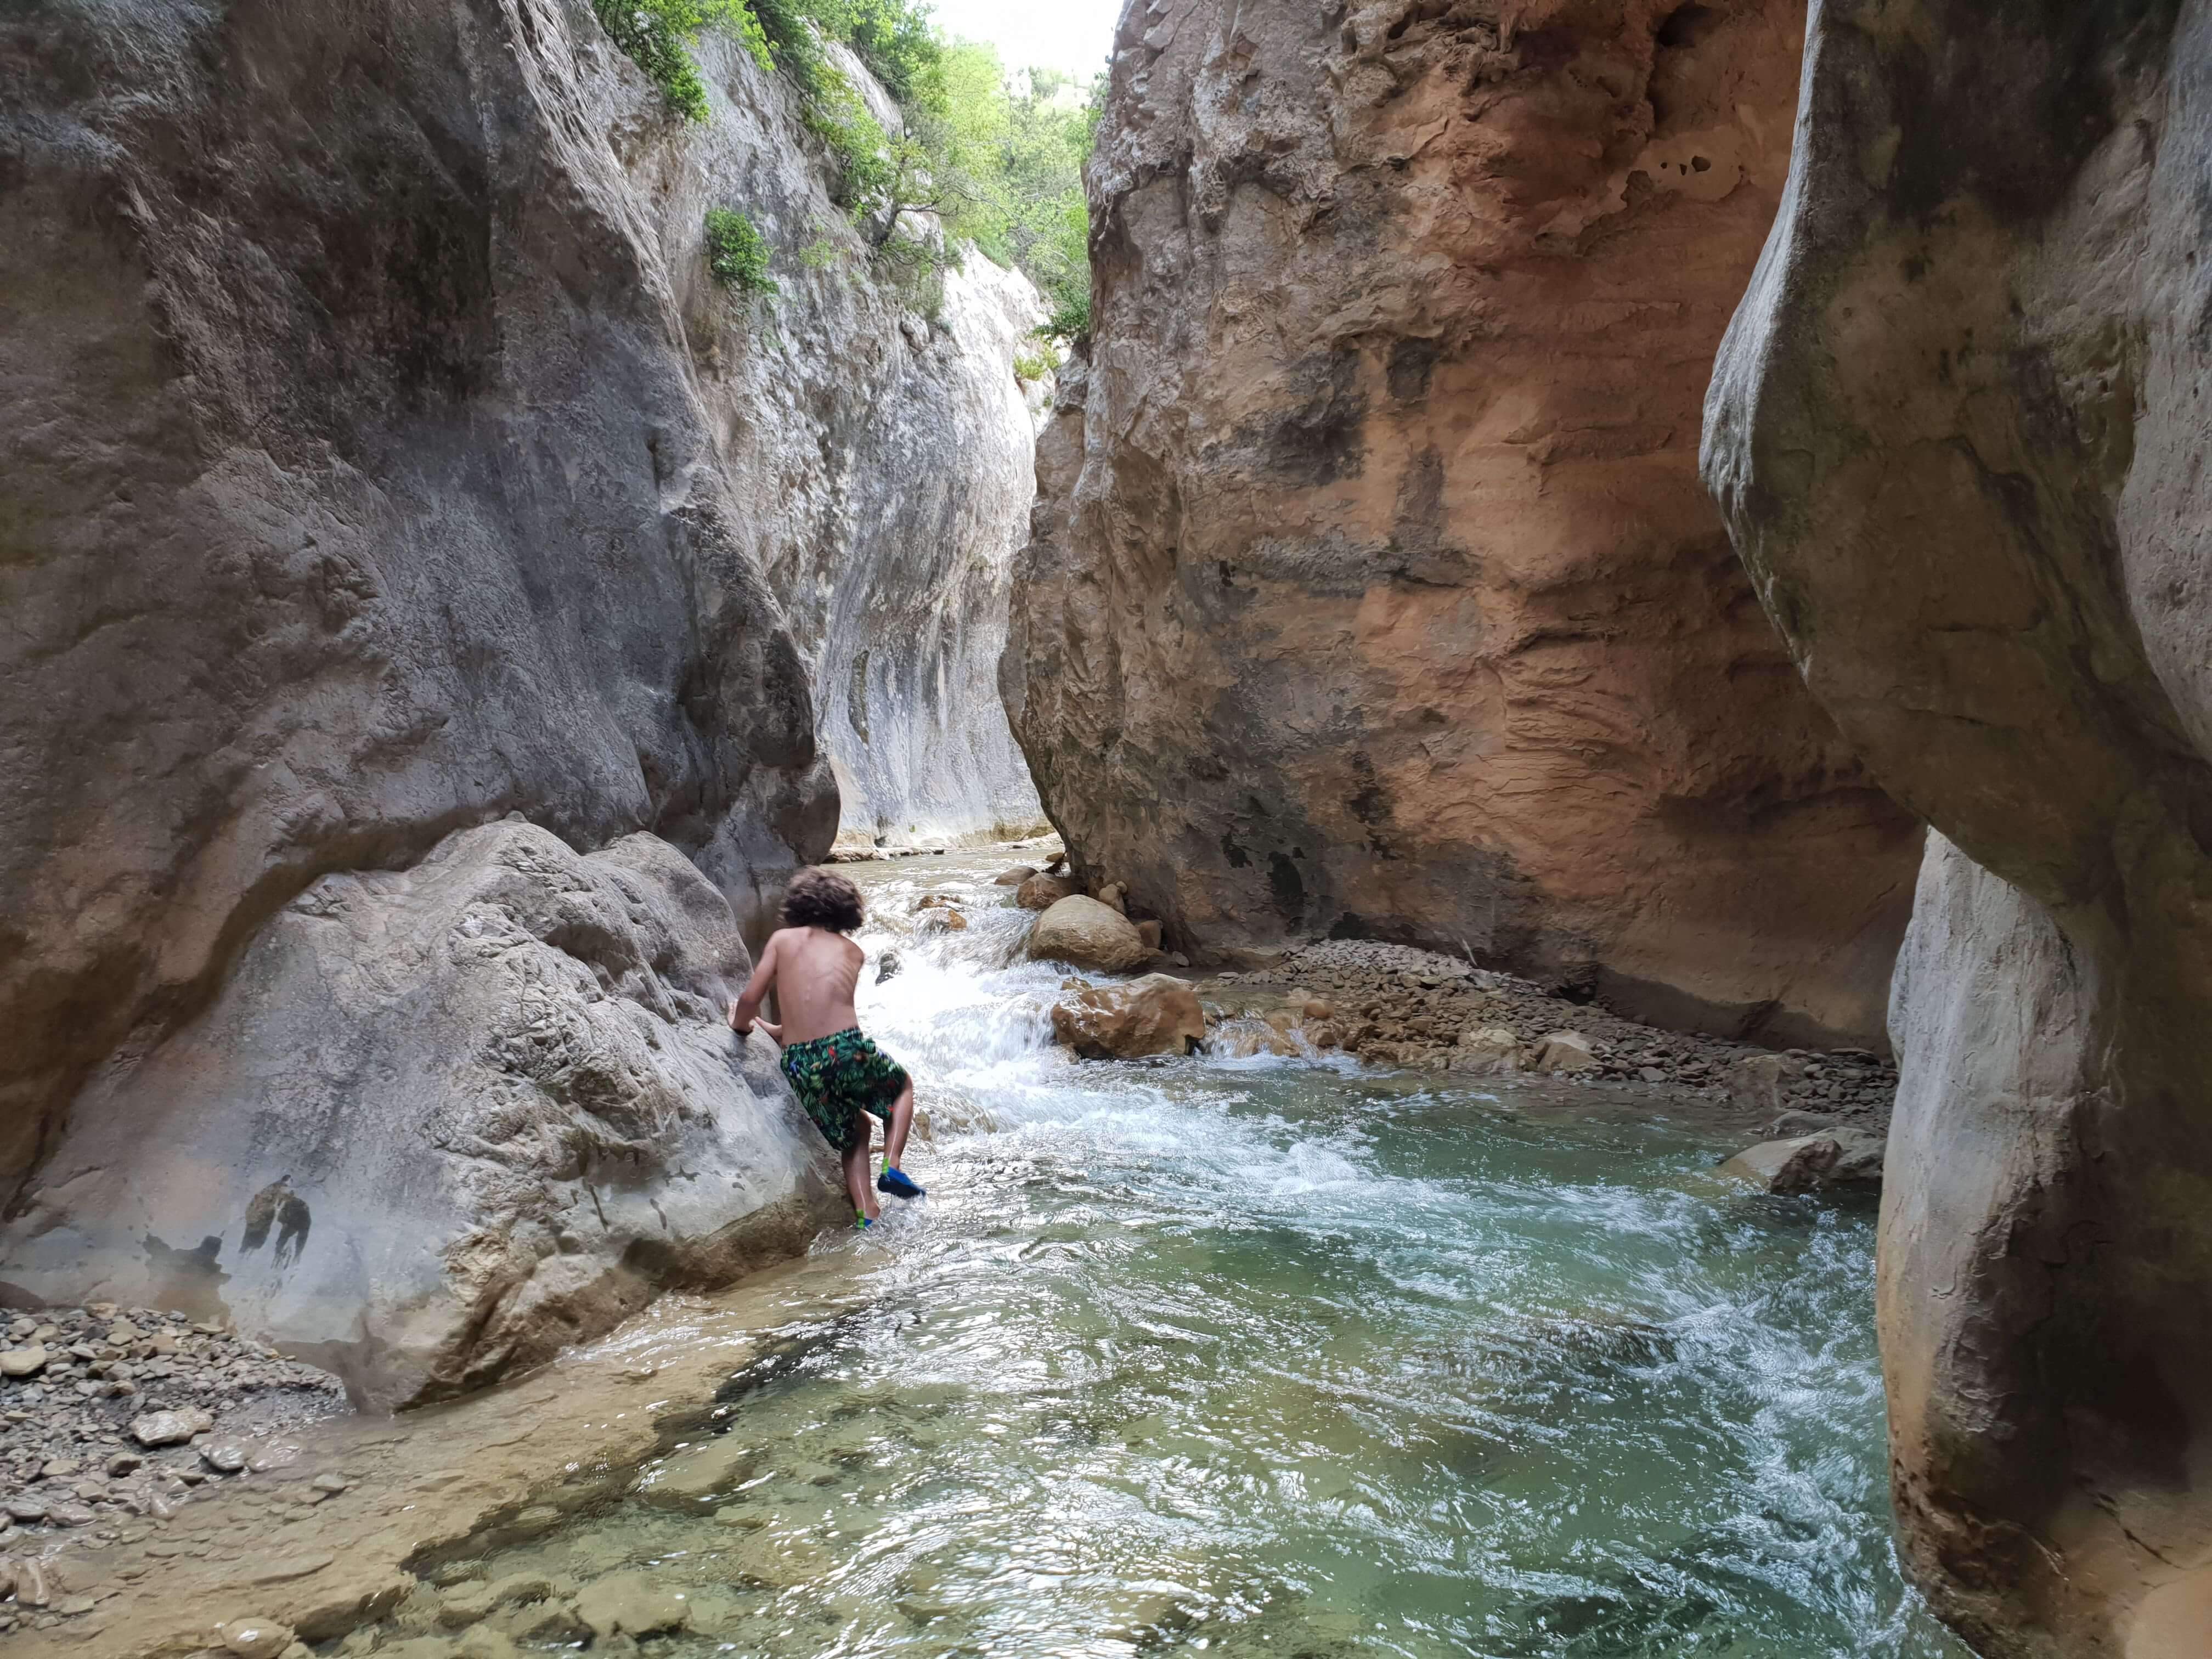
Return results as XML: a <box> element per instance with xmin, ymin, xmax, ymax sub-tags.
<box><xmin>0</xmin><ymin>1303</ymin><xmax>345</xmax><ymax>1633</ymax></box>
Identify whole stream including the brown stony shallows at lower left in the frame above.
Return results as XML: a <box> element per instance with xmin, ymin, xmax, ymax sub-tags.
<box><xmin>0</xmin><ymin>849</ymin><xmax>1964</xmax><ymax>1659</ymax></box>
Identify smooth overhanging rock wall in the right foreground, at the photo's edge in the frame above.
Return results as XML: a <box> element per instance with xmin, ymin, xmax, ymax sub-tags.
<box><xmin>1706</xmin><ymin>0</ymin><xmax>2212</xmax><ymax>1659</ymax></box>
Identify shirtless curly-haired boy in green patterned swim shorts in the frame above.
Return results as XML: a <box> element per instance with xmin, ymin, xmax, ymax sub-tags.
<box><xmin>730</xmin><ymin>870</ymin><xmax>922</xmax><ymax>1228</ymax></box>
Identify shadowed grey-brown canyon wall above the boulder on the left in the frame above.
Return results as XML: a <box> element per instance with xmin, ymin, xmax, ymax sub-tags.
<box><xmin>0</xmin><ymin>0</ymin><xmax>836</xmax><ymax>1212</ymax></box>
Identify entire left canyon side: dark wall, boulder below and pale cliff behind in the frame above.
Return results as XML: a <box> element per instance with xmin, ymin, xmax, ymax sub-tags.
<box><xmin>0</xmin><ymin>0</ymin><xmax>1029</xmax><ymax>1402</ymax></box>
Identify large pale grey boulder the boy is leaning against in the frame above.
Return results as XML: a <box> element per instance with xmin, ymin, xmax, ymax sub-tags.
<box><xmin>0</xmin><ymin>823</ymin><xmax>840</xmax><ymax>1407</ymax></box>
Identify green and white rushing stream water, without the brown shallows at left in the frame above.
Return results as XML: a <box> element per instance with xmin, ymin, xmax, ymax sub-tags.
<box><xmin>376</xmin><ymin>858</ymin><xmax>1964</xmax><ymax>1659</ymax></box>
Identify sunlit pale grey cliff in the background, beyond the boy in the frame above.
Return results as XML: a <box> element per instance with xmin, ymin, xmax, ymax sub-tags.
<box><xmin>654</xmin><ymin>24</ymin><xmax>1044</xmax><ymax>847</ymax></box>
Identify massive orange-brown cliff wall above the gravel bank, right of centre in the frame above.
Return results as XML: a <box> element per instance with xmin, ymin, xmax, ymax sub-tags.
<box><xmin>1002</xmin><ymin>0</ymin><xmax>1920</xmax><ymax>1044</ymax></box>
